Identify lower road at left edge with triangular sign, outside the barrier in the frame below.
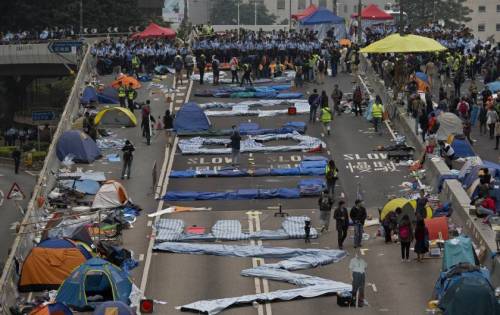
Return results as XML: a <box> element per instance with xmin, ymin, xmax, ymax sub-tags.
<box><xmin>0</xmin><ymin>165</ymin><xmax>37</xmax><ymax>265</ymax></box>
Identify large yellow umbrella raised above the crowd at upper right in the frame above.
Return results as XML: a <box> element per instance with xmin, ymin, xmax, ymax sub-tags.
<box><xmin>361</xmin><ymin>34</ymin><xmax>447</xmax><ymax>54</ymax></box>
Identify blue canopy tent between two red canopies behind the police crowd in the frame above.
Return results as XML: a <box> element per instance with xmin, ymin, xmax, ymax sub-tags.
<box><xmin>299</xmin><ymin>8</ymin><xmax>346</xmax><ymax>40</ymax></box>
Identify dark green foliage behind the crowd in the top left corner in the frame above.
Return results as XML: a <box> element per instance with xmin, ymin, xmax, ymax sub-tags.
<box><xmin>0</xmin><ymin>0</ymin><xmax>145</xmax><ymax>32</ymax></box>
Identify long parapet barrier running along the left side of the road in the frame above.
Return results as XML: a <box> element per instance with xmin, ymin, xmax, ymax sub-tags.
<box><xmin>0</xmin><ymin>46</ymin><xmax>95</xmax><ymax>314</ymax></box>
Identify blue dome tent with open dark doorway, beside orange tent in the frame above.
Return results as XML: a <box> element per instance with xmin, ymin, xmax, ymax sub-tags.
<box><xmin>56</xmin><ymin>258</ymin><xmax>132</xmax><ymax>310</ymax></box>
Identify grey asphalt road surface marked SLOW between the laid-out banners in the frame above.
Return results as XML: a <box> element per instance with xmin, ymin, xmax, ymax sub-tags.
<box><xmin>138</xmin><ymin>71</ymin><xmax>440</xmax><ymax>315</ymax></box>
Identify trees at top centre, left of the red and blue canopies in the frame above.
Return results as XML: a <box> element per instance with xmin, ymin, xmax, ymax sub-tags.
<box><xmin>210</xmin><ymin>0</ymin><xmax>276</xmax><ymax>25</ymax></box>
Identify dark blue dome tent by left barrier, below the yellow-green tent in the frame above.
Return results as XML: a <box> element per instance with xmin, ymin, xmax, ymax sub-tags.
<box><xmin>56</xmin><ymin>130</ymin><xmax>101</xmax><ymax>163</ymax></box>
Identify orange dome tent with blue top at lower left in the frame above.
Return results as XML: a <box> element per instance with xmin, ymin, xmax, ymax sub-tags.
<box><xmin>19</xmin><ymin>239</ymin><xmax>92</xmax><ymax>292</ymax></box>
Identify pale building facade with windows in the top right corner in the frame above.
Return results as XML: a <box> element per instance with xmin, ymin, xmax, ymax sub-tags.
<box><xmin>466</xmin><ymin>0</ymin><xmax>500</xmax><ymax>42</ymax></box>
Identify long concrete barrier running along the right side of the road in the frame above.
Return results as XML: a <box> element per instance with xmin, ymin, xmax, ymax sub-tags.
<box><xmin>361</xmin><ymin>56</ymin><xmax>500</xmax><ymax>286</ymax></box>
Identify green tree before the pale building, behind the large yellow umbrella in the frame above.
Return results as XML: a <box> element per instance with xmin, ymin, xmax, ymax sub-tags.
<box><xmin>398</xmin><ymin>0</ymin><xmax>472</xmax><ymax>28</ymax></box>
